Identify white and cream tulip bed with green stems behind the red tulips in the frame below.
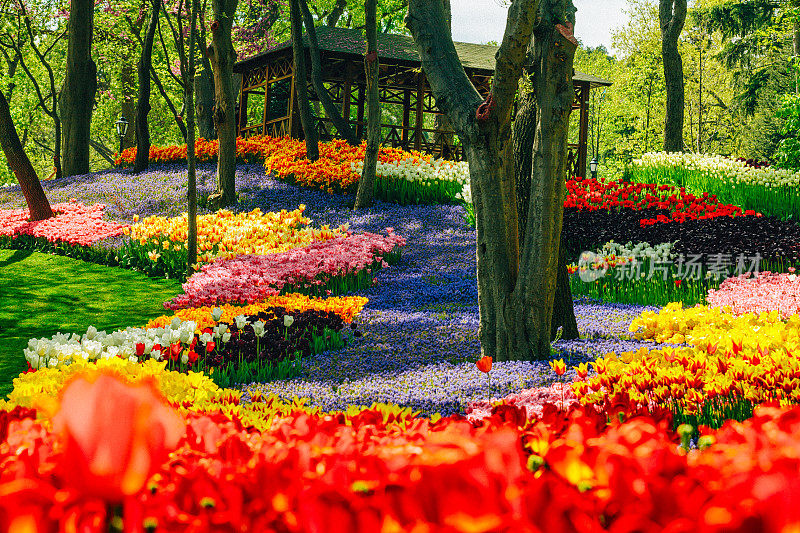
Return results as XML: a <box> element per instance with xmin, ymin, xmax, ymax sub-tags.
<box><xmin>625</xmin><ymin>153</ymin><xmax>800</xmax><ymax>220</ymax></box>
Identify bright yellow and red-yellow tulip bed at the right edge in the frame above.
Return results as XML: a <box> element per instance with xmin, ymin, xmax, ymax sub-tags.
<box><xmin>573</xmin><ymin>303</ymin><xmax>800</xmax><ymax>427</ymax></box>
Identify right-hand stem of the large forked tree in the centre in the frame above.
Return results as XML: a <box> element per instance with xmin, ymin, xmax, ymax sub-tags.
<box><xmin>505</xmin><ymin>10</ymin><xmax>578</xmax><ymax>359</ymax></box>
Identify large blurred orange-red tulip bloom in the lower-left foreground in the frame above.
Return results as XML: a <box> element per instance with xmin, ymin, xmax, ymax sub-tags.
<box><xmin>53</xmin><ymin>373</ymin><xmax>184</xmax><ymax>502</ymax></box>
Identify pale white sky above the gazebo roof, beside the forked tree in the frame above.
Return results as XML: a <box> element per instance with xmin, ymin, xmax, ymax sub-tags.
<box><xmin>450</xmin><ymin>0</ymin><xmax>627</xmax><ymax>51</ymax></box>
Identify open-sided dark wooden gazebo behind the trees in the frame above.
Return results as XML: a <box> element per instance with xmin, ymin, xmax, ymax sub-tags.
<box><xmin>234</xmin><ymin>26</ymin><xmax>611</xmax><ymax>174</ymax></box>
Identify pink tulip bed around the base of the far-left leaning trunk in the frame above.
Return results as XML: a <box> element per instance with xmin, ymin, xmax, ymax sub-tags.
<box><xmin>0</xmin><ymin>200</ymin><xmax>126</xmax><ymax>248</ymax></box>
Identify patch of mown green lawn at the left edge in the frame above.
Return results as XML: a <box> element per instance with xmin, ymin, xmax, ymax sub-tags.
<box><xmin>0</xmin><ymin>250</ymin><xmax>180</xmax><ymax>398</ymax></box>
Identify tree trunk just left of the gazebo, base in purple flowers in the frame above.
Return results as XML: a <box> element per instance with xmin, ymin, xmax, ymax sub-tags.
<box><xmin>208</xmin><ymin>0</ymin><xmax>238</xmax><ymax>206</ymax></box>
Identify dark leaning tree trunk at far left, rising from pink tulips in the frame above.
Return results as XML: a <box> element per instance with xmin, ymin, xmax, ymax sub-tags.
<box><xmin>0</xmin><ymin>91</ymin><xmax>53</xmax><ymax>220</ymax></box>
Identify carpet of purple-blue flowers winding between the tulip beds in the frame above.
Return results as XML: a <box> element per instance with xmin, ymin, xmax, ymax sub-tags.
<box><xmin>0</xmin><ymin>164</ymin><xmax>668</xmax><ymax>415</ymax></box>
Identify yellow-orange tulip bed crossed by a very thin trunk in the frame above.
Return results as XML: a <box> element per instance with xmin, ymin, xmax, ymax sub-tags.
<box><xmin>119</xmin><ymin>205</ymin><xmax>343</xmax><ymax>278</ymax></box>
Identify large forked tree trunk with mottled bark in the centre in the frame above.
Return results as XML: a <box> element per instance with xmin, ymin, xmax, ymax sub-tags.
<box><xmin>406</xmin><ymin>0</ymin><xmax>577</xmax><ymax>361</ymax></box>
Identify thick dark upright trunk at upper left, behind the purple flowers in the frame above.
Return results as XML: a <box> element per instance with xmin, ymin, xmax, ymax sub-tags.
<box><xmin>59</xmin><ymin>0</ymin><xmax>97</xmax><ymax>176</ymax></box>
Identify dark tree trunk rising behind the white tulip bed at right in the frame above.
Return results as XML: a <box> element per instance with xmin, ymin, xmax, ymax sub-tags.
<box><xmin>658</xmin><ymin>0</ymin><xmax>686</xmax><ymax>152</ymax></box>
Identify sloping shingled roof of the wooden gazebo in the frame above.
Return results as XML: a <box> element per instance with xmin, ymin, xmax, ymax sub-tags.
<box><xmin>234</xmin><ymin>26</ymin><xmax>612</xmax><ymax>87</ymax></box>
